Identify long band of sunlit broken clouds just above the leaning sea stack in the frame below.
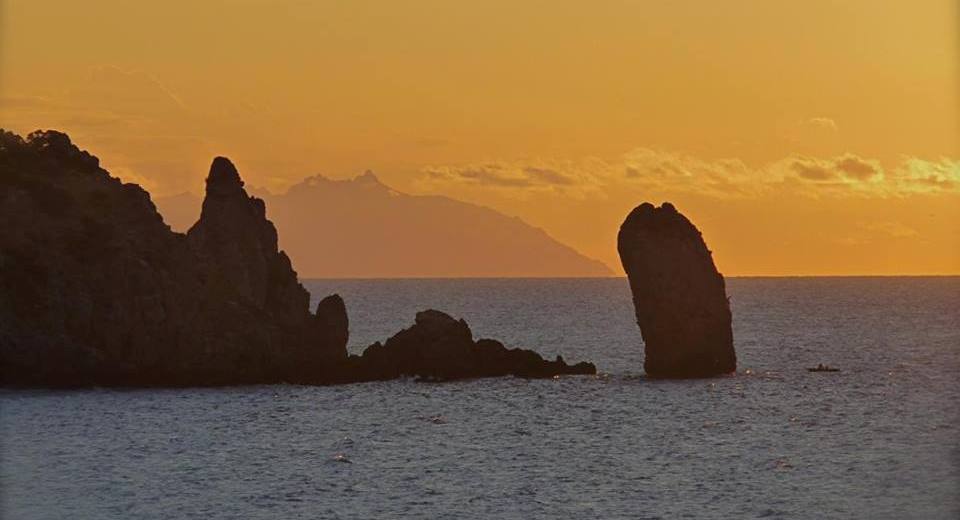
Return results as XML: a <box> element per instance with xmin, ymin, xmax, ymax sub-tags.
<box><xmin>418</xmin><ymin>148</ymin><xmax>960</xmax><ymax>199</ymax></box>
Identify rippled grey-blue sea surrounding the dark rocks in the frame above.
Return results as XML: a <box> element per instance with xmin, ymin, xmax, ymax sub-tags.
<box><xmin>0</xmin><ymin>278</ymin><xmax>960</xmax><ymax>519</ymax></box>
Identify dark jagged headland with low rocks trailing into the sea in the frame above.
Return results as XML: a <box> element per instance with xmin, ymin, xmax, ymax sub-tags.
<box><xmin>0</xmin><ymin>131</ymin><xmax>592</xmax><ymax>387</ymax></box>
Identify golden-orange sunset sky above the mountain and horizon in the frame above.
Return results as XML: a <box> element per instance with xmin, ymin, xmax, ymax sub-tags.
<box><xmin>0</xmin><ymin>0</ymin><xmax>960</xmax><ymax>275</ymax></box>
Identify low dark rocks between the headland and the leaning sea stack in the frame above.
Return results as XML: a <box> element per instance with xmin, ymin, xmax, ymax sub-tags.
<box><xmin>351</xmin><ymin>310</ymin><xmax>596</xmax><ymax>381</ymax></box>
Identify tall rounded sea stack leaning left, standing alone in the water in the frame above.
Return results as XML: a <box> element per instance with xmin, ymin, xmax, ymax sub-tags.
<box><xmin>617</xmin><ymin>202</ymin><xmax>737</xmax><ymax>378</ymax></box>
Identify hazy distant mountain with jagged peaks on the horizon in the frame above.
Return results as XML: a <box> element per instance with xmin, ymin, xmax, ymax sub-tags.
<box><xmin>155</xmin><ymin>172</ymin><xmax>613</xmax><ymax>278</ymax></box>
